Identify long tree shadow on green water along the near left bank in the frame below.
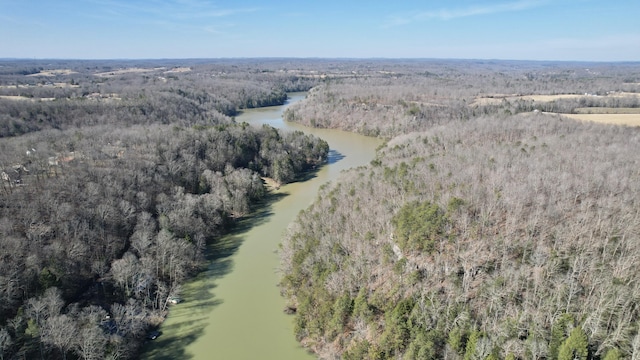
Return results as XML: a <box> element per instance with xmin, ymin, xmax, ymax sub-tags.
<box><xmin>141</xmin><ymin>192</ymin><xmax>289</xmax><ymax>360</ymax></box>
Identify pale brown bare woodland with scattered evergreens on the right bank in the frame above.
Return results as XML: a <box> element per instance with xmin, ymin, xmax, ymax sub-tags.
<box><xmin>281</xmin><ymin>61</ymin><xmax>640</xmax><ymax>360</ymax></box>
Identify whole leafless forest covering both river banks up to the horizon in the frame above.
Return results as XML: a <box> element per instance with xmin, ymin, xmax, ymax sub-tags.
<box><xmin>0</xmin><ymin>59</ymin><xmax>640</xmax><ymax>360</ymax></box>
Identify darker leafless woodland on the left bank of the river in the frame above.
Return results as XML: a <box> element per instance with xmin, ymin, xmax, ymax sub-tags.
<box><xmin>0</xmin><ymin>61</ymin><xmax>329</xmax><ymax>359</ymax></box>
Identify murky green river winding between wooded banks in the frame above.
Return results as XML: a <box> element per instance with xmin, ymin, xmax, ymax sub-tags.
<box><xmin>142</xmin><ymin>93</ymin><xmax>382</xmax><ymax>360</ymax></box>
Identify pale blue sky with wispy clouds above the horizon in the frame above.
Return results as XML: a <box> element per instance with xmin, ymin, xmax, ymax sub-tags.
<box><xmin>0</xmin><ymin>0</ymin><xmax>640</xmax><ymax>61</ymax></box>
